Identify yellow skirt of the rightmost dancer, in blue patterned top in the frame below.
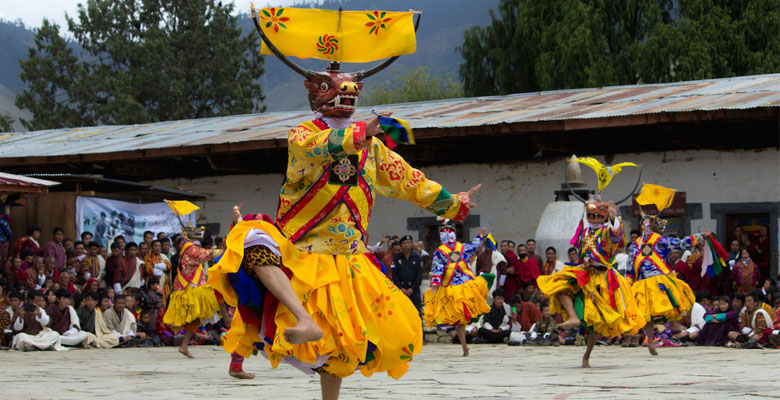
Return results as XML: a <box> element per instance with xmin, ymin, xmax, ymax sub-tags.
<box><xmin>631</xmin><ymin>273</ymin><xmax>696</xmax><ymax>322</ymax></box>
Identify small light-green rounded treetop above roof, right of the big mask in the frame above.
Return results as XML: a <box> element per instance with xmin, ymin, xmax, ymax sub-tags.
<box><xmin>360</xmin><ymin>66</ymin><xmax>463</xmax><ymax>106</ymax></box>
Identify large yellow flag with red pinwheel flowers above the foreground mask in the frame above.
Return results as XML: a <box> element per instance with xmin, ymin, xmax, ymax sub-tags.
<box><xmin>252</xmin><ymin>7</ymin><xmax>417</xmax><ymax>62</ymax></box>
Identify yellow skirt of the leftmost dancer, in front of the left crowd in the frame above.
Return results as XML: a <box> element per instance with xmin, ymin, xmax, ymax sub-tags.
<box><xmin>163</xmin><ymin>284</ymin><xmax>219</xmax><ymax>327</ymax></box>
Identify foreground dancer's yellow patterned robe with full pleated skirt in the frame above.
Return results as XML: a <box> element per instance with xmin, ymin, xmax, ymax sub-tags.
<box><xmin>209</xmin><ymin>120</ymin><xmax>468</xmax><ymax>379</ymax></box>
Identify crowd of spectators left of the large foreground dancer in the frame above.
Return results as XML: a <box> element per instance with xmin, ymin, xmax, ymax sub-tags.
<box><xmin>0</xmin><ymin>223</ymin><xmax>229</xmax><ymax>351</ymax></box>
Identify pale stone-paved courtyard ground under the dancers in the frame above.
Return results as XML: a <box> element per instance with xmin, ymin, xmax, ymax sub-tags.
<box><xmin>0</xmin><ymin>344</ymin><xmax>780</xmax><ymax>400</ymax></box>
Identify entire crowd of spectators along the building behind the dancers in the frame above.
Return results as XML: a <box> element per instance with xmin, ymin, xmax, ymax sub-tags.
<box><xmin>0</xmin><ymin>218</ymin><xmax>780</xmax><ymax>350</ymax></box>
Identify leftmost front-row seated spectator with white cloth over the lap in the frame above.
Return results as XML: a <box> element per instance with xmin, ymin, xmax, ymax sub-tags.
<box><xmin>11</xmin><ymin>291</ymin><xmax>65</xmax><ymax>351</ymax></box>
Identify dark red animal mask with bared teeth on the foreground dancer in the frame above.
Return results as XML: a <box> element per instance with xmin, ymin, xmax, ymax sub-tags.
<box><xmin>303</xmin><ymin>71</ymin><xmax>363</xmax><ymax>118</ymax></box>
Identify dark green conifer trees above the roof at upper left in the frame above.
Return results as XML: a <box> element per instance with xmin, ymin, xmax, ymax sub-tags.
<box><xmin>16</xmin><ymin>0</ymin><xmax>265</xmax><ymax>129</ymax></box>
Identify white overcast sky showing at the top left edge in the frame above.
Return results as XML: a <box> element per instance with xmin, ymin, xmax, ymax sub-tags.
<box><xmin>0</xmin><ymin>0</ymin><xmax>300</xmax><ymax>28</ymax></box>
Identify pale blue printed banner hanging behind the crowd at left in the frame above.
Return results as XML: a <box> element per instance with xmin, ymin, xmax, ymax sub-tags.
<box><xmin>76</xmin><ymin>196</ymin><xmax>196</xmax><ymax>247</ymax></box>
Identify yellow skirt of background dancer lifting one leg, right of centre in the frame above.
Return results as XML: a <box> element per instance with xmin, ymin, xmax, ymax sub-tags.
<box><xmin>536</xmin><ymin>266</ymin><xmax>645</xmax><ymax>336</ymax></box>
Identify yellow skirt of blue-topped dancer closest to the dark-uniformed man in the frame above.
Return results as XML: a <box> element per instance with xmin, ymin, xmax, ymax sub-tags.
<box><xmin>423</xmin><ymin>277</ymin><xmax>490</xmax><ymax>327</ymax></box>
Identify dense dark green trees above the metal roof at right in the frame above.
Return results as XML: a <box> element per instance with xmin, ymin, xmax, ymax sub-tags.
<box><xmin>459</xmin><ymin>0</ymin><xmax>780</xmax><ymax>96</ymax></box>
